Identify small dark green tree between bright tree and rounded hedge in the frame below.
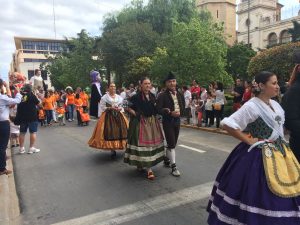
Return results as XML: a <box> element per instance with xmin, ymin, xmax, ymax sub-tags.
<box><xmin>226</xmin><ymin>43</ymin><xmax>256</xmax><ymax>80</ymax></box>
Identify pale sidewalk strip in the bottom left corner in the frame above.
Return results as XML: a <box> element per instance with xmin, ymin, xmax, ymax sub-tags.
<box><xmin>0</xmin><ymin>149</ymin><xmax>21</xmax><ymax>225</ymax></box>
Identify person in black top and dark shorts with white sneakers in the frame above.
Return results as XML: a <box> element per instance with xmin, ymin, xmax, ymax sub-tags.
<box><xmin>15</xmin><ymin>84</ymin><xmax>40</xmax><ymax>154</ymax></box>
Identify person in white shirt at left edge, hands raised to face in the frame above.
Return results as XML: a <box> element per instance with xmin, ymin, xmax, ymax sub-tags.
<box><xmin>0</xmin><ymin>79</ymin><xmax>22</xmax><ymax>175</ymax></box>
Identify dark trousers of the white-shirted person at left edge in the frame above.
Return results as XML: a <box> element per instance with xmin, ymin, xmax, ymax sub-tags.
<box><xmin>0</xmin><ymin>120</ymin><xmax>10</xmax><ymax>172</ymax></box>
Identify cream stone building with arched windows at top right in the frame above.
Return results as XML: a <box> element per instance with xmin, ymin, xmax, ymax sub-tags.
<box><xmin>237</xmin><ymin>0</ymin><xmax>300</xmax><ymax>51</ymax></box>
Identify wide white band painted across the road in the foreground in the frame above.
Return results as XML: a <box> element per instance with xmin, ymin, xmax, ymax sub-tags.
<box><xmin>53</xmin><ymin>182</ymin><xmax>213</xmax><ymax>225</ymax></box>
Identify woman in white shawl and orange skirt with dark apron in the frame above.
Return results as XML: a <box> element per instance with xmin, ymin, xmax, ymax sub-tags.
<box><xmin>88</xmin><ymin>83</ymin><xmax>128</xmax><ymax>158</ymax></box>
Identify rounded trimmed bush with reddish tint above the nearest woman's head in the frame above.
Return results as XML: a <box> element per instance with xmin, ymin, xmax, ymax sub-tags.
<box><xmin>248</xmin><ymin>42</ymin><xmax>300</xmax><ymax>82</ymax></box>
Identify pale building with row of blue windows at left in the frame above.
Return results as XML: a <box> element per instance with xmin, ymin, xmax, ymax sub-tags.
<box><xmin>10</xmin><ymin>37</ymin><xmax>64</xmax><ymax>87</ymax></box>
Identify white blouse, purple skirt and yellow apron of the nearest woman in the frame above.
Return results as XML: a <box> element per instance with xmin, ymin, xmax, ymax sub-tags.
<box><xmin>207</xmin><ymin>98</ymin><xmax>300</xmax><ymax>225</ymax></box>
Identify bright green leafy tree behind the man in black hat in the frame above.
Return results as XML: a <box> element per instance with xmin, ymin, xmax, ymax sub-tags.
<box><xmin>152</xmin><ymin>18</ymin><xmax>232</xmax><ymax>84</ymax></box>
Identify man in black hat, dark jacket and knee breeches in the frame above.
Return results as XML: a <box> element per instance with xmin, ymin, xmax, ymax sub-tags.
<box><xmin>157</xmin><ymin>72</ymin><xmax>184</xmax><ymax>177</ymax></box>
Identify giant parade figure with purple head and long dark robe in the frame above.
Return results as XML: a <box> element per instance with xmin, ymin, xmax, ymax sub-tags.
<box><xmin>90</xmin><ymin>71</ymin><xmax>102</xmax><ymax>118</ymax></box>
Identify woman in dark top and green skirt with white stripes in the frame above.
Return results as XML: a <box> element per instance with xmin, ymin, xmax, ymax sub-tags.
<box><xmin>124</xmin><ymin>77</ymin><xmax>165</xmax><ymax>180</ymax></box>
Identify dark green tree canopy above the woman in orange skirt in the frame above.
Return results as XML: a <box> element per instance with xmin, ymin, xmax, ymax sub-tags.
<box><xmin>102</xmin><ymin>22</ymin><xmax>160</xmax><ymax>84</ymax></box>
